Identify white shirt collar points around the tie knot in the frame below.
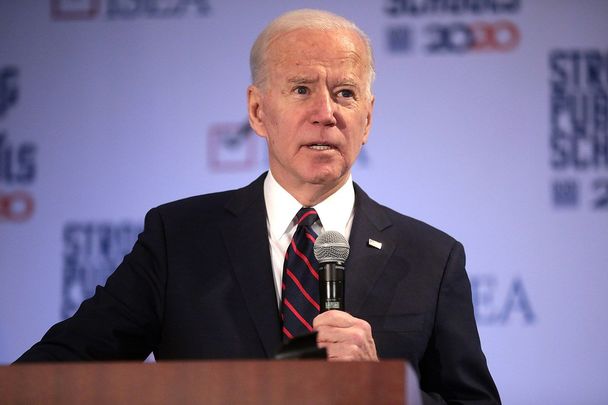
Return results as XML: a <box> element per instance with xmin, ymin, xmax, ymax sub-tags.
<box><xmin>264</xmin><ymin>171</ymin><xmax>355</xmax><ymax>240</ymax></box>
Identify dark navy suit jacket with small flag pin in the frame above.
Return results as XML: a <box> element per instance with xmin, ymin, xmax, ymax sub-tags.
<box><xmin>18</xmin><ymin>175</ymin><xmax>499</xmax><ymax>404</ymax></box>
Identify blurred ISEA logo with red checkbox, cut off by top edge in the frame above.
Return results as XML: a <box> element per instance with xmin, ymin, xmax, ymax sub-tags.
<box><xmin>51</xmin><ymin>0</ymin><xmax>211</xmax><ymax>21</ymax></box>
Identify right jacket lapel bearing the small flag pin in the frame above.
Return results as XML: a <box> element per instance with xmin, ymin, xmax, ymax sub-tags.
<box><xmin>344</xmin><ymin>184</ymin><xmax>395</xmax><ymax>316</ymax></box>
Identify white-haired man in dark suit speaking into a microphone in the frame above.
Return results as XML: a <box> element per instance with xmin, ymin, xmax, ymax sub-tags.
<box><xmin>19</xmin><ymin>10</ymin><xmax>499</xmax><ymax>404</ymax></box>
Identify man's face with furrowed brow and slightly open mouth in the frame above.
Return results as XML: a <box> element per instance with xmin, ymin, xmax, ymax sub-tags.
<box><xmin>249</xmin><ymin>29</ymin><xmax>373</xmax><ymax>197</ymax></box>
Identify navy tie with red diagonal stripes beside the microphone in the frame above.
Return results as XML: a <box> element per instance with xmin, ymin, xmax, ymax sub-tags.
<box><xmin>281</xmin><ymin>208</ymin><xmax>319</xmax><ymax>340</ymax></box>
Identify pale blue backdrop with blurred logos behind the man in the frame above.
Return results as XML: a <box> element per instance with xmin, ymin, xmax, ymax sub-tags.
<box><xmin>0</xmin><ymin>0</ymin><xmax>608</xmax><ymax>404</ymax></box>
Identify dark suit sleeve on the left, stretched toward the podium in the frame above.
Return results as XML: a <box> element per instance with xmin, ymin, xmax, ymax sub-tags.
<box><xmin>16</xmin><ymin>209</ymin><xmax>167</xmax><ymax>362</ymax></box>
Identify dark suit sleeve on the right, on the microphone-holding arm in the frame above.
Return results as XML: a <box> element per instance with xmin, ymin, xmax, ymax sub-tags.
<box><xmin>420</xmin><ymin>241</ymin><xmax>500</xmax><ymax>405</ymax></box>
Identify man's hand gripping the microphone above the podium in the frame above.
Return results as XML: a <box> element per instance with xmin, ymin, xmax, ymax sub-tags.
<box><xmin>312</xmin><ymin>310</ymin><xmax>378</xmax><ymax>361</ymax></box>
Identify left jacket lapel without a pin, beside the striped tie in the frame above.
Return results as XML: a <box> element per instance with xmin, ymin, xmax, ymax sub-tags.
<box><xmin>222</xmin><ymin>175</ymin><xmax>281</xmax><ymax>357</ymax></box>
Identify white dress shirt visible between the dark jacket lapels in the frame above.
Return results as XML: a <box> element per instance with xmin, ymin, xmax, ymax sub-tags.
<box><xmin>264</xmin><ymin>171</ymin><xmax>355</xmax><ymax>308</ymax></box>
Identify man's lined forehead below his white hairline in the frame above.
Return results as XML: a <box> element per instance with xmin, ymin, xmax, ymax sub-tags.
<box><xmin>267</xmin><ymin>29</ymin><xmax>366</xmax><ymax>77</ymax></box>
